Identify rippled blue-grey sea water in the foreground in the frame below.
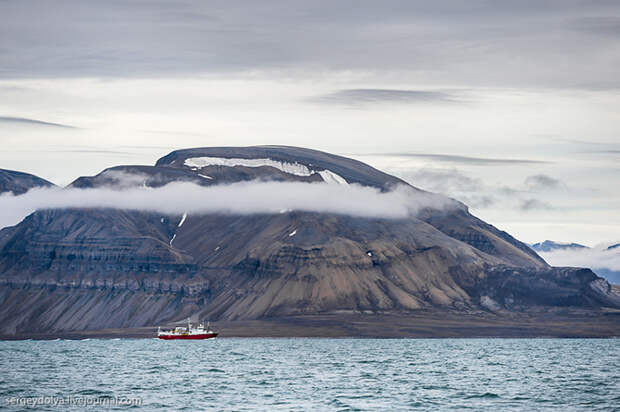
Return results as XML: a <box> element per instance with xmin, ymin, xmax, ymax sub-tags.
<box><xmin>0</xmin><ymin>338</ymin><xmax>620</xmax><ymax>411</ymax></box>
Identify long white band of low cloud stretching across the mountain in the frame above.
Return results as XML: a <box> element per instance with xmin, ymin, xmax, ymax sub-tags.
<box><xmin>0</xmin><ymin>182</ymin><xmax>462</xmax><ymax>227</ymax></box>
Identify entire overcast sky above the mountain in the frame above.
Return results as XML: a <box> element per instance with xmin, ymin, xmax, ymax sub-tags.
<box><xmin>0</xmin><ymin>0</ymin><xmax>620</xmax><ymax>245</ymax></box>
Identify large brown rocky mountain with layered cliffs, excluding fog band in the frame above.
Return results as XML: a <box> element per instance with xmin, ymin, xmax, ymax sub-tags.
<box><xmin>0</xmin><ymin>146</ymin><xmax>620</xmax><ymax>333</ymax></box>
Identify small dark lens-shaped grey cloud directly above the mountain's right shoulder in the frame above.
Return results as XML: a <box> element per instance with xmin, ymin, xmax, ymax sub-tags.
<box><xmin>310</xmin><ymin>89</ymin><xmax>458</xmax><ymax>106</ymax></box>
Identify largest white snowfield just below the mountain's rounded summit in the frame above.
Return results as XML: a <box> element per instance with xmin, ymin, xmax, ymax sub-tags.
<box><xmin>185</xmin><ymin>157</ymin><xmax>348</xmax><ymax>185</ymax></box>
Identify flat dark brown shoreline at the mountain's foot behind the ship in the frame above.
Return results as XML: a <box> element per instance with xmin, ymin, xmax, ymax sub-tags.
<box><xmin>0</xmin><ymin>310</ymin><xmax>620</xmax><ymax>340</ymax></box>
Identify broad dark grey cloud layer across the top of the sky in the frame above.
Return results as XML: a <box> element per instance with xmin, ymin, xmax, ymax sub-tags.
<box><xmin>0</xmin><ymin>0</ymin><xmax>620</xmax><ymax>87</ymax></box>
